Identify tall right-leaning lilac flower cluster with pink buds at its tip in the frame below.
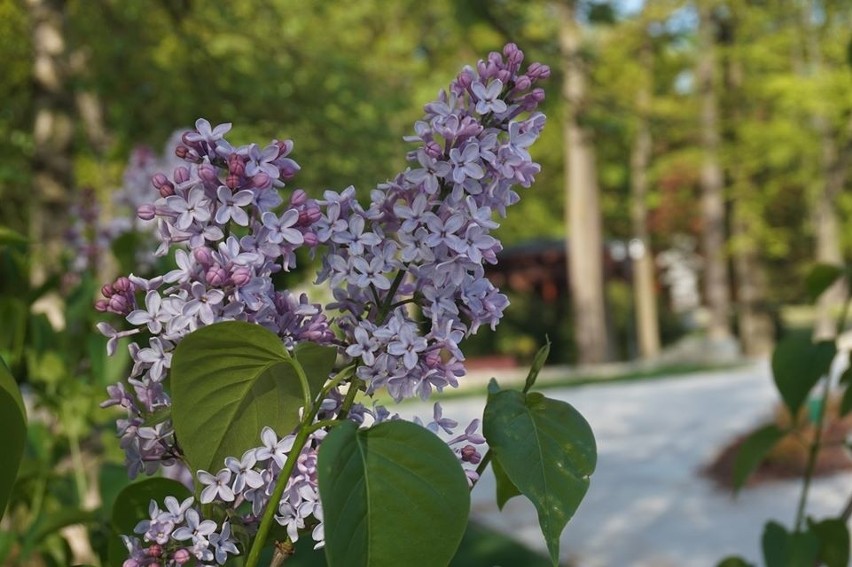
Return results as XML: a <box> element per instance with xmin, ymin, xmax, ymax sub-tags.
<box><xmin>317</xmin><ymin>44</ymin><xmax>549</xmax><ymax>400</ymax></box>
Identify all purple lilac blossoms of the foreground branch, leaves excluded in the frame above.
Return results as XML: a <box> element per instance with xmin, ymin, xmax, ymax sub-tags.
<box><xmin>96</xmin><ymin>44</ymin><xmax>549</xmax><ymax>567</ymax></box>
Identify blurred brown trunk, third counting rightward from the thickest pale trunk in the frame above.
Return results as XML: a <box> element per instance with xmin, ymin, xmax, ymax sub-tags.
<box><xmin>698</xmin><ymin>2</ymin><xmax>732</xmax><ymax>342</ymax></box>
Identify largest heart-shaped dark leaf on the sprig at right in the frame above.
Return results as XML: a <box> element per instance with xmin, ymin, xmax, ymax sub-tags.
<box><xmin>772</xmin><ymin>336</ymin><xmax>837</xmax><ymax>420</ymax></box>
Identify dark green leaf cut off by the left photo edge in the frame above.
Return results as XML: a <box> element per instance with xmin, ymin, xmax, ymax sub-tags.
<box><xmin>0</xmin><ymin>359</ymin><xmax>27</xmax><ymax>518</ymax></box>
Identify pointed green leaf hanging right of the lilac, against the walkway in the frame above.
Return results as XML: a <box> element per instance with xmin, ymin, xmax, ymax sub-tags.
<box><xmin>483</xmin><ymin>390</ymin><xmax>597</xmax><ymax>565</ymax></box>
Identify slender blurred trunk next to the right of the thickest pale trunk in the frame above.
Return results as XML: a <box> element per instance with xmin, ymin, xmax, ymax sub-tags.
<box><xmin>629</xmin><ymin>42</ymin><xmax>660</xmax><ymax>359</ymax></box>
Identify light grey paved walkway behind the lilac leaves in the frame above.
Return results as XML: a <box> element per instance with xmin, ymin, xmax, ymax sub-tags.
<box><xmin>404</xmin><ymin>363</ymin><xmax>852</xmax><ymax>567</ymax></box>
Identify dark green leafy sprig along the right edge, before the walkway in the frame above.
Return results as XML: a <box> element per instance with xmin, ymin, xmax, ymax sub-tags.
<box><xmin>718</xmin><ymin>264</ymin><xmax>852</xmax><ymax>567</ymax></box>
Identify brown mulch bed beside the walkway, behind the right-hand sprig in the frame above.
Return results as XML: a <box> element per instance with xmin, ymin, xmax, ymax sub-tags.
<box><xmin>701</xmin><ymin>410</ymin><xmax>852</xmax><ymax>490</ymax></box>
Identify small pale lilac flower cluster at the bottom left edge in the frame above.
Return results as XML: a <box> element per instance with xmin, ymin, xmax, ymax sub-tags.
<box><xmin>121</xmin><ymin>496</ymin><xmax>240</xmax><ymax>567</ymax></box>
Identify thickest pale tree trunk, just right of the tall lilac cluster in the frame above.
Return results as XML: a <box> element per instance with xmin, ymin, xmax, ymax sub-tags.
<box><xmin>557</xmin><ymin>0</ymin><xmax>608</xmax><ymax>364</ymax></box>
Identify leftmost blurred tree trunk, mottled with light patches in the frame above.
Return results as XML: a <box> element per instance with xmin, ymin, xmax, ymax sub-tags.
<box><xmin>27</xmin><ymin>0</ymin><xmax>74</xmax><ymax>284</ymax></box>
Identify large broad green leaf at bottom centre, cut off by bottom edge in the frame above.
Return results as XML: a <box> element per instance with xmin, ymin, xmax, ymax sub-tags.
<box><xmin>317</xmin><ymin>421</ymin><xmax>470</xmax><ymax>567</ymax></box>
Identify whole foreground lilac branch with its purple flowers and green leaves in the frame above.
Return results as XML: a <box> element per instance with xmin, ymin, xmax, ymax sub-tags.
<box><xmin>0</xmin><ymin>44</ymin><xmax>596</xmax><ymax>567</ymax></box>
